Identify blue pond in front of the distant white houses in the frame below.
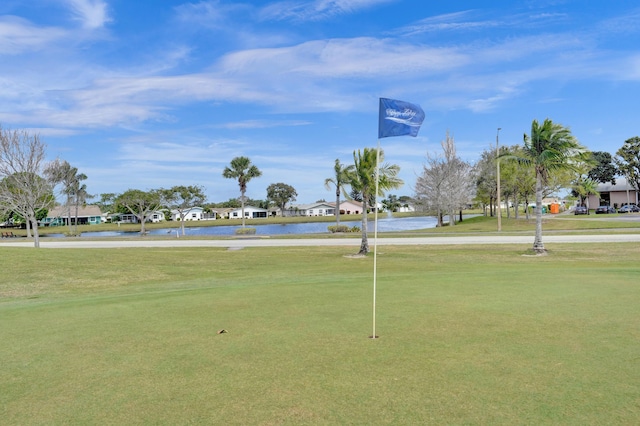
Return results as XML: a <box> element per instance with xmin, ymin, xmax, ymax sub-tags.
<box><xmin>47</xmin><ymin>216</ymin><xmax>437</xmax><ymax>237</ymax></box>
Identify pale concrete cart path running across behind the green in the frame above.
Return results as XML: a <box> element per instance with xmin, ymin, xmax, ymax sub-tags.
<box><xmin>0</xmin><ymin>234</ymin><xmax>640</xmax><ymax>249</ymax></box>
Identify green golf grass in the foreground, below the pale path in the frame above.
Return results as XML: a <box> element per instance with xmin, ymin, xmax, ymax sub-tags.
<box><xmin>0</xmin><ymin>244</ymin><xmax>640</xmax><ymax>425</ymax></box>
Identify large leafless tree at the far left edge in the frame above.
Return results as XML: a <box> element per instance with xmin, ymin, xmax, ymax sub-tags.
<box><xmin>0</xmin><ymin>127</ymin><xmax>55</xmax><ymax>247</ymax></box>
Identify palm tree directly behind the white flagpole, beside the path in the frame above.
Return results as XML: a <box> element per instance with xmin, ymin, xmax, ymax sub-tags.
<box><xmin>349</xmin><ymin>148</ymin><xmax>403</xmax><ymax>254</ymax></box>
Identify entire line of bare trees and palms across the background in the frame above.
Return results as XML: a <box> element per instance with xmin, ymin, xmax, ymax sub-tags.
<box><xmin>0</xmin><ymin>119</ymin><xmax>640</xmax><ymax>254</ymax></box>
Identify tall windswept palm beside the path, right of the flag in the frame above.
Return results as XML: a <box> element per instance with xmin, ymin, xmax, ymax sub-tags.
<box><xmin>521</xmin><ymin>118</ymin><xmax>588</xmax><ymax>254</ymax></box>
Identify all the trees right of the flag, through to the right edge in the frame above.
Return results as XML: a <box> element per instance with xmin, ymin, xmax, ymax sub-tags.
<box><xmin>415</xmin><ymin>119</ymin><xmax>640</xmax><ymax>253</ymax></box>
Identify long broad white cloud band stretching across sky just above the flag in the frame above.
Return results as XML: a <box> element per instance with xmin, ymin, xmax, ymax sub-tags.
<box><xmin>0</xmin><ymin>26</ymin><xmax>629</xmax><ymax>128</ymax></box>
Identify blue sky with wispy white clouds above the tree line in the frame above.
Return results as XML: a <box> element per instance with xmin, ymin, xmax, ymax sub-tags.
<box><xmin>0</xmin><ymin>0</ymin><xmax>640</xmax><ymax>203</ymax></box>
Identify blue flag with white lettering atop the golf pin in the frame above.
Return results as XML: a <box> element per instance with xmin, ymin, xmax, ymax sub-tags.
<box><xmin>378</xmin><ymin>98</ymin><xmax>424</xmax><ymax>139</ymax></box>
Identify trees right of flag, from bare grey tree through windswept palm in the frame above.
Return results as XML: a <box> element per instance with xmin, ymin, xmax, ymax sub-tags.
<box><xmin>416</xmin><ymin>119</ymin><xmax>592</xmax><ymax>253</ymax></box>
